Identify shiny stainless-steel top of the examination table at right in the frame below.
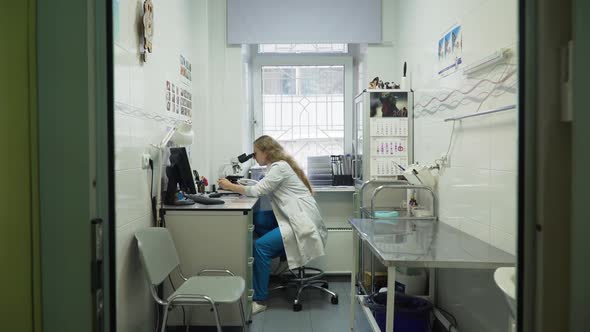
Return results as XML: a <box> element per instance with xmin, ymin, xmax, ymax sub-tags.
<box><xmin>348</xmin><ymin>218</ymin><xmax>516</xmax><ymax>269</ymax></box>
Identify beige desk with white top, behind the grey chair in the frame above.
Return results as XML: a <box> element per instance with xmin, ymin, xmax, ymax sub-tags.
<box><xmin>162</xmin><ymin>195</ymin><xmax>258</xmax><ymax>326</ymax></box>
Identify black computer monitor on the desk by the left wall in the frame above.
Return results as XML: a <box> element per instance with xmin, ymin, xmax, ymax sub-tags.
<box><xmin>164</xmin><ymin>148</ymin><xmax>197</xmax><ymax>204</ymax></box>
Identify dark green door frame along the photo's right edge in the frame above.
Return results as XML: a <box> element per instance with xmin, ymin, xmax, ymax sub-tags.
<box><xmin>518</xmin><ymin>0</ymin><xmax>590</xmax><ymax>332</ymax></box>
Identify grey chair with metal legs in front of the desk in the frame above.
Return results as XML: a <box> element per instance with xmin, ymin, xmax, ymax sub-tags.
<box><xmin>135</xmin><ymin>227</ymin><xmax>246</xmax><ymax>332</ymax></box>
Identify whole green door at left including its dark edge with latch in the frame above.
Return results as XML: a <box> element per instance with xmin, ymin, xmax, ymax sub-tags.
<box><xmin>33</xmin><ymin>0</ymin><xmax>114</xmax><ymax>332</ymax></box>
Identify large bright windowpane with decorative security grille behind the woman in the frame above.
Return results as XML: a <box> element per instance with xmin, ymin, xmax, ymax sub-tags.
<box><xmin>257</xmin><ymin>65</ymin><xmax>345</xmax><ymax>169</ymax></box>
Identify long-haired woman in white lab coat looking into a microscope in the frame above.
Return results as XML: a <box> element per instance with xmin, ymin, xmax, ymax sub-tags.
<box><xmin>218</xmin><ymin>136</ymin><xmax>328</xmax><ymax>314</ymax></box>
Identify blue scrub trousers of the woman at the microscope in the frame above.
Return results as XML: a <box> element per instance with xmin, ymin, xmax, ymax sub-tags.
<box><xmin>253</xmin><ymin>210</ymin><xmax>285</xmax><ymax>301</ymax></box>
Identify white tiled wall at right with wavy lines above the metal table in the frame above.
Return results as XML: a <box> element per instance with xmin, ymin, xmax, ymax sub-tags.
<box><xmin>396</xmin><ymin>0</ymin><xmax>518</xmax><ymax>254</ymax></box>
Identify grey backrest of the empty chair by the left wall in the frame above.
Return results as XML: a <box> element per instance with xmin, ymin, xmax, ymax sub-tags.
<box><xmin>135</xmin><ymin>227</ymin><xmax>180</xmax><ymax>285</ymax></box>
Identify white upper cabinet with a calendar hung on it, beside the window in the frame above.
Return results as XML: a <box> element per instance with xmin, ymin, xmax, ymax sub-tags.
<box><xmin>352</xmin><ymin>90</ymin><xmax>414</xmax><ymax>182</ymax></box>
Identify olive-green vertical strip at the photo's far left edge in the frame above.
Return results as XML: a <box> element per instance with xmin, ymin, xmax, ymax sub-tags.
<box><xmin>0</xmin><ymin>0</ymin><xmax>41</xmax><ymax>332</ymax></box>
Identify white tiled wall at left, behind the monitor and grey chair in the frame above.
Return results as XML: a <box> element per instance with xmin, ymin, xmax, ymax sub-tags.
<box><xmin>114</xmin><ymin>0</ymin><xmax>208</xmax><ymax>332</ymax></box>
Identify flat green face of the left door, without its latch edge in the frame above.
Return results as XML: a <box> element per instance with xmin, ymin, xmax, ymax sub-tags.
<box><xmin>37</xmin><ymin>0</ymin><xmax>94</xmax><ymax>332</ymax></box>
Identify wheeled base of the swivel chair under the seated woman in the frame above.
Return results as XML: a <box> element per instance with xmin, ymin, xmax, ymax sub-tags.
<box><xmin>271</xmin><ymin>256</ymin><xmax>338</xmax><ymax>311</ymax></box>
